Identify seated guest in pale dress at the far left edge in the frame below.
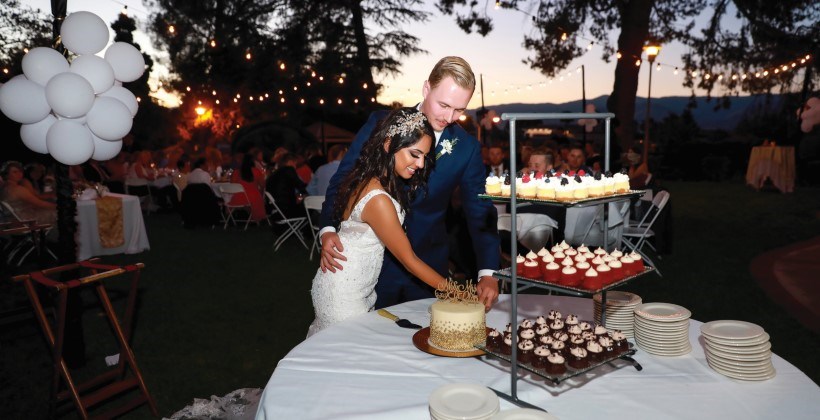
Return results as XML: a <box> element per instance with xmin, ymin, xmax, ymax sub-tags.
<box><xmin>0</xmin><ymin>161</ymin><xmax>57</xmax><ymax>224</ymax></box>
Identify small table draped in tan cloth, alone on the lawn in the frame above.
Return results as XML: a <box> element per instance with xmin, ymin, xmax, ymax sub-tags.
<box><xmin>746</xmin><ymin>146</ymin><xmax>795</xmax><ymax>193</ymax></box>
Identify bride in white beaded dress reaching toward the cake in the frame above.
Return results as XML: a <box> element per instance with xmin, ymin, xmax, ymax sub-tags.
<box><xmin>308</xmin><ymin>108</ymin><xmax>445</xmax><ymax>337</ymax></box>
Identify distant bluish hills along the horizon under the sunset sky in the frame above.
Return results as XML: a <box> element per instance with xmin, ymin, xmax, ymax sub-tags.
<box><xmin>470</xmin><ymin>95</ymin><xmax>782</xmax><ymax>131</ymax></box>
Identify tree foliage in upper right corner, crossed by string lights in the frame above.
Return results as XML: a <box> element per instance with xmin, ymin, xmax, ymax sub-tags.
<box><xmin>683</xmin><ymin>0</ymin><xmax>820</xmax><ymax>101</ymax></box>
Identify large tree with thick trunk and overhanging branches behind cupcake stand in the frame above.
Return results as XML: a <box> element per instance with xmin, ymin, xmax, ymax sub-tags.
<box><xmin>437</xmin><ymin>0</ymin><xmax>707</xmax><ymax>148</ymax></box>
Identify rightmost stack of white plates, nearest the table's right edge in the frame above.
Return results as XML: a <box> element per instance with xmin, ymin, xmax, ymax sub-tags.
<box><xmin>700</xmin><ymin>320</ymin><xmax>775</xmax><ymax>381</ymax></box>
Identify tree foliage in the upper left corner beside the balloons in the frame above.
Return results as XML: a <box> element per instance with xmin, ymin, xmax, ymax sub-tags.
<box><xmin>0</xmin><ymin>0</ymin><xmax>51</xmax><ymax>81</ymax></box>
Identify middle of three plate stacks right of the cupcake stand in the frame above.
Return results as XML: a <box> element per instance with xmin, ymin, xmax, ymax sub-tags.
<box><xmin>635</xmin><ymin>302</ymin><xmax>692</xmax><ymax>356</ymax></box>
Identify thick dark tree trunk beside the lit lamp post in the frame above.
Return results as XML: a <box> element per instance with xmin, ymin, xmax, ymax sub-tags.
<box><xmin>606</xmin><ymin>0</ymin><xmax>654</xmax><ymax>154</ymax></box>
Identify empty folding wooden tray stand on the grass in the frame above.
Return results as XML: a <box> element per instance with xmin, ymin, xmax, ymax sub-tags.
<box><xmin>13</xmin><ymin>259</ymin><xmax>158</xmax><ymax>419</ymax></box>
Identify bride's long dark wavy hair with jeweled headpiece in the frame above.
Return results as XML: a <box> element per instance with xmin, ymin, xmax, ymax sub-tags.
<box><xmin>333</xmin><ymin>108</ymin><xmax>435</xmax><ymax>223</ymax></box>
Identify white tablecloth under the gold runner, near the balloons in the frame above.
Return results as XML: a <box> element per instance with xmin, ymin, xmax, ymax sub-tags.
<box><xmin>76</xmin><ymin>194</ymin><xmax>151</xmax><ymax>260</ymax></box>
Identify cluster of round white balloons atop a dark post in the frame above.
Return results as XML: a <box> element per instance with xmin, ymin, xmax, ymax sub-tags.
<box><xmin>0</xmin><ymin>12</ymin><xmax>145</xmax><ymax>165</ymax></box>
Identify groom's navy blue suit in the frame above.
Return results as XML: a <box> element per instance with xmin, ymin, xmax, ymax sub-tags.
<box><xmin>322</xmin><ymin>111</ymin><xmax>500</xmax><ymax>308</ymax></box>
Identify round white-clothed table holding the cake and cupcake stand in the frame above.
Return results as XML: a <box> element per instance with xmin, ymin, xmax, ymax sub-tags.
<box><xmin>257</xmin><ymin>295</ymin><xmax>820</xmax><ymax>420</ymax></box>
